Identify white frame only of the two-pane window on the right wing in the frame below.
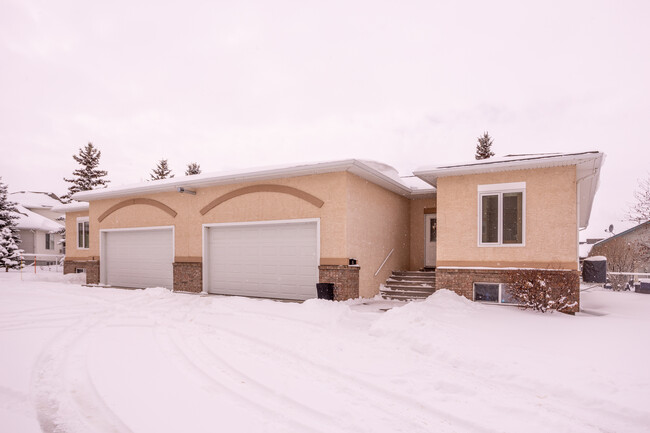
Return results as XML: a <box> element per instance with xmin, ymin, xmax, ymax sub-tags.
<box><xmin>477</xmin><ymin>182</ymin><xmax>526</xmax><ymax>248</ymax></box>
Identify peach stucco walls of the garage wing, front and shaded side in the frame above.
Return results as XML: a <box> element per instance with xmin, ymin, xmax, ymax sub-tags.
<box><xmin>71</xmin><ymin>172</ymin><xmax>422</xmax><ymax>297</ymax></box>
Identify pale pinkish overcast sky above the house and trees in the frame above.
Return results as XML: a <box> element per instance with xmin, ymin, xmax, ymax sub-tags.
<box><xmin>0</xmin><ymin>0</ymin><xmax>650</xmax><ymax>236</ymax></box>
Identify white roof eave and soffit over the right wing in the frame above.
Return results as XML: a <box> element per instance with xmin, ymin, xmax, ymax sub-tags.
<box><xmin>413</xmin><ymin>151</ymin><xmax>605</xmax><ymax>228</ymax></box>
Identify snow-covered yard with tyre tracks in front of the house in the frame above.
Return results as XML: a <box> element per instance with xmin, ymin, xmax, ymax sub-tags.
<box><xmin>0</xmin><ymin>272</ymin><xmax>650</xmax><ymax>433</ymax></box>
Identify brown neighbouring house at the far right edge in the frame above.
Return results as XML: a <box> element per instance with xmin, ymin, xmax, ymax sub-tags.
<box><xmin>589</xmin><ymin>221</ymin><xmax>650</xmax><ymax>273</ymax></box>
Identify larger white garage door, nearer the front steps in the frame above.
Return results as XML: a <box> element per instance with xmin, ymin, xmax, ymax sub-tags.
<box><xmin>206</xmin><ymin>221</ymin><xmax>318</xmax><ymax>299</ymax></box>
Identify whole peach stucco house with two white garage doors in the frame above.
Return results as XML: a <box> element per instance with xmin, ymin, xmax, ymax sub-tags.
<box><xmin>56</xmin><ymin>152</ymin><xmax>603</xmax><ymax>308</ymax></box>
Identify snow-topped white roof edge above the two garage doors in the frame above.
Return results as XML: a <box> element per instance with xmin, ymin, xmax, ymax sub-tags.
<box><xmin>73</xmin><ymin>159</ymin><xmax>435</xmax><ymax>201</ymax></box>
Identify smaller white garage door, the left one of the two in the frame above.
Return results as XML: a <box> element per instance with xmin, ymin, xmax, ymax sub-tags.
<box><xmin>100</xmin><ymin>228</ymin><xmax>174</xmax><ymax>289</ymax></box>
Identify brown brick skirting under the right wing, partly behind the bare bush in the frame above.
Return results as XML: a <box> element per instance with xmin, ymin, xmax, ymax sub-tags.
<box><xmin>436</xmin><ymin>268</ymin><xmax>580</xmax><ymax>313</ymax></box>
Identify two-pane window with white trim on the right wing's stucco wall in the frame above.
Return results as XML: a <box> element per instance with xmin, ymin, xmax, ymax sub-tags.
<box><xmin>478</xmin><ymin>182</ymin><xmax>526</xmax><ymax>246</ymax></box>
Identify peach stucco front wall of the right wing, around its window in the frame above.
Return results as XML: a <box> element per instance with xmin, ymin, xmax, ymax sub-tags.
<box><xmin>437</xmin><ymin>166</ymin><xmax>578</xmax><ymax>270</ymax></box>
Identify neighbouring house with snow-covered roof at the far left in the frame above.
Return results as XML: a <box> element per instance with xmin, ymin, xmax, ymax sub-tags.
<box><xmin>9</xmin><ymin>191</ymin><xmax>65</xmax><ymax>264</ymax></box>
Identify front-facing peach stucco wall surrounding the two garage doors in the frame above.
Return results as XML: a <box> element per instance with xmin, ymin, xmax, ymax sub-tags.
<box><xmin>88</xmin><ymin>173</ymin><xmax>347</xmax><ymax>259</ymax></box>
